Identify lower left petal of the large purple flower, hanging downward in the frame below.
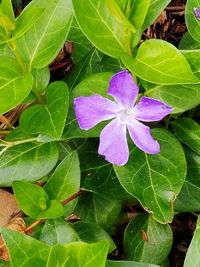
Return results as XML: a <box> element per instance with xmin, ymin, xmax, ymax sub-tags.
<box><xmin>98</xmin><ymin>118</ymin><xmax>129</xmax><ymax>166</ymax></box>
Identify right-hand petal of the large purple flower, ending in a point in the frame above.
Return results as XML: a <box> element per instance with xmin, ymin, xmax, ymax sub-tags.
<box><xmin>133</xmin><ymin>97</ymin><xmax>173</xmax><ymax>121</ymax></box>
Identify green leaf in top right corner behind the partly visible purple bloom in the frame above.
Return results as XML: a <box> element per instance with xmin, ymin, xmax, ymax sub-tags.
<box><xmin>185</xmin><ymin>0</ymin><xmax>200</xmax><ymax>42</ymax></box>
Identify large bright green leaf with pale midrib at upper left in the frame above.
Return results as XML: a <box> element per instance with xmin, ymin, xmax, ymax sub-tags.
<box><xmin>16</xmin><ymin>0</ymin><xmax>72</xmax><ymax>68</ymax></box>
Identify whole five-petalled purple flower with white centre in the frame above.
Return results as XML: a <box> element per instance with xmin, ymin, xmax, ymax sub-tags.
<box><xmin>74</xmin><ymin>70</ymin><xmax>172</xmax><ymax>166</ymax></box>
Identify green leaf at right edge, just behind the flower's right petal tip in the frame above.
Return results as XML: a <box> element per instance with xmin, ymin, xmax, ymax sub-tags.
<box><xmin>146</xmin><ymin>84</ymin><xmax>200</xmax><ymax>114</ymax></box>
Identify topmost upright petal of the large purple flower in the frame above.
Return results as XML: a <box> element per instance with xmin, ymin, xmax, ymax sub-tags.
<box><xmin>107</xmin><ymin>70</ymin><xmax>139</xmax><ymax>108</ymax></box>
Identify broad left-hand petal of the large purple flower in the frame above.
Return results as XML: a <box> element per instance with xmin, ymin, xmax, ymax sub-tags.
<box><xmin>74</xmin><ymin>94</ymin><xmax>119</xmax><ymax>130</ymax></box>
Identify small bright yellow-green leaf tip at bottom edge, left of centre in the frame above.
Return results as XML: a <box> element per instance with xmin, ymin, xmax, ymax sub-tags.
<box><xmin>46</xmin><ymin>245</ymin><xmax>70</xmax><ymax>267</ymax></box>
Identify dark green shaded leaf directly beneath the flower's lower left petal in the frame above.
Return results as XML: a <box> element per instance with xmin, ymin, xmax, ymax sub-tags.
<box><xmin>78</xmin><ymin>139</ymin><xmax>131</xmax><ymax>201</ymax></box>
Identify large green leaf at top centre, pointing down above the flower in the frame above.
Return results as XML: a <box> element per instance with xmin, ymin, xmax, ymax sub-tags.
<box><xmin>73</xmin><ymin>0</ymin><xmax>132</xmax><ymax>58</ymax></box>
